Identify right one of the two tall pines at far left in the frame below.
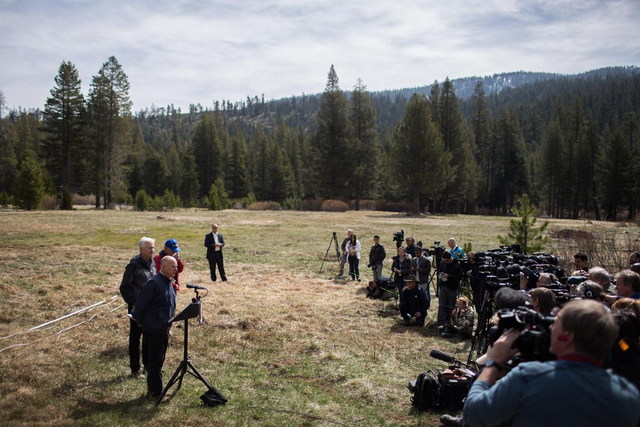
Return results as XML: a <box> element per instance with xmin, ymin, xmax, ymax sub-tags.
<box><xmin>88</xmin><ymin>56</ymin><xmax>131</xmax><ymax>209</ymax></box>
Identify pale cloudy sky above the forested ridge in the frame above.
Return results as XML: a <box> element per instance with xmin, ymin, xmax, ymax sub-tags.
<box><xmin>0</xmin><ymin>0</ymin><xmax>640</xmax><ymax>110</ymax></box>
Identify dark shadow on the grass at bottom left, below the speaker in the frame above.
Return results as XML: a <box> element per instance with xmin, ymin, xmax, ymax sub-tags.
<box><xmin>71</xmin><ymin>395</ymin><xmax>157</xmax><ymax>424</ymax></box>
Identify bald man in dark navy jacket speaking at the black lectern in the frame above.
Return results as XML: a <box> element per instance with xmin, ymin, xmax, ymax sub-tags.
<box><xmin>131</xmin><ymin>256</ymin><xmax>178</xmax><ymax>399</ymax></box>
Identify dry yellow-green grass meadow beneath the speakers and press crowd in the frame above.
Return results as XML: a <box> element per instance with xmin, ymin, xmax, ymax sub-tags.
<box><xmin>0</xmin><ymin>210</ymin><xmax>638</xmax><ymax>426</ymax></box>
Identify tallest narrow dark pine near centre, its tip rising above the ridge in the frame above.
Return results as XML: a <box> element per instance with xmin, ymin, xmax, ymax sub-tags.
<box><xmin>315</xmin><ymin>65</ymin><xmax>353</xmax><ymax>199</ymax></box>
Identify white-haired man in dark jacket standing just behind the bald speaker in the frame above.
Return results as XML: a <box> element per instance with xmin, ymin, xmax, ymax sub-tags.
<box><xmin>120</xmin><ymin>237</ymin><xmax>156</xmax><ymax>377</ymax></box>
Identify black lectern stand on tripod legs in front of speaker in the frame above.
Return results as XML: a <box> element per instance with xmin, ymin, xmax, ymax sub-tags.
<box><xmin>156</xmin><ymin>299</ymin><xmax>228</xmax><ymax>406</ymax></box>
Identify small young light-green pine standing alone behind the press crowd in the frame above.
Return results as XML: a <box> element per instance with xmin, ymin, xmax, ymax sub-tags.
<box><xmin>498</xmin><ymin>194</ymin><xmax>549</xmax><ymax>254</ymax></box>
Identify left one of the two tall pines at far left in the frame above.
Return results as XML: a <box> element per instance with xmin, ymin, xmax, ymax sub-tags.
<box><xmin>43</xmin><ymin>61</ymin><xmax>85</xmax><ymax>209</ymax></box>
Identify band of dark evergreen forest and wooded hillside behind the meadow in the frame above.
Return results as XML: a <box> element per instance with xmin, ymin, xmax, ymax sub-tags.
<box><xmin>0</xmin><ymin>57</ymin><xmax>640</xmax><ymax>219</ymax></box>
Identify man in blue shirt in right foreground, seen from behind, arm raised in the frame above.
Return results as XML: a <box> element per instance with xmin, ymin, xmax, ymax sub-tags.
<box><xmin>464</xmin><ymin>300</ymin><xmax>640</xmax><ymax>427</ymax></box>
